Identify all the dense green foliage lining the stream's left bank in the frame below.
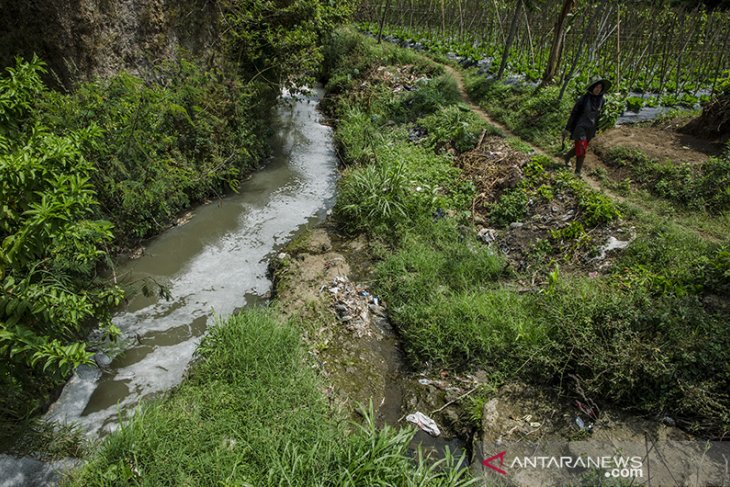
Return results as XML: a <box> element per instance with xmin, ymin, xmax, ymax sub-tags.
<box><xmin>0</xmin><ymin>0</ymin><xmax>351</xmax><ymax>423</ymax></box>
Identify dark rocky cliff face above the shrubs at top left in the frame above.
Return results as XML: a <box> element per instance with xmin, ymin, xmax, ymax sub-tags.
<box><xmin>0</xmin><ymin>0</ymin><xmax>219</xmax><ymax>85</ymax></box>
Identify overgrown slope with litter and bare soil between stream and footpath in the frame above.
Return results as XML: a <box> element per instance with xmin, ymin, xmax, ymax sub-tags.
<box><xmin>322</xmin><ymin>31</ymin><xmax>728</xmax><ymax>485</ymax></box>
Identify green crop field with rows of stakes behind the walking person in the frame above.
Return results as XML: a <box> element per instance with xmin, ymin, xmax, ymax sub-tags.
<box><xmin>358</xmin><ymin>0</ymin><xmax>730</xmax><ymax>109</ymax></box>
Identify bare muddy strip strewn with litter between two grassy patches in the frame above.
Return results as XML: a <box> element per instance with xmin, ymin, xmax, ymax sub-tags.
<box><xmin>270</xmin><ymin>227</ymin><xmax>470</xmax><ymax>458</ymax></box>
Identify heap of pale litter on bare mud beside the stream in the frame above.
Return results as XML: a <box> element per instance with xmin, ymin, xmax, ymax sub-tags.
<box><xmin>320</xmin><ymin>276</ymin><xmax>386</xmax><ymax>338</ymax></box>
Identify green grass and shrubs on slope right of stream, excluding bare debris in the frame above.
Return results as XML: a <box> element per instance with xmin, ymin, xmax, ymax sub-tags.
<box><xmin>328</xmin><ymin>31</ymin><xmax>730</xmax><ymax>437</ymax></box>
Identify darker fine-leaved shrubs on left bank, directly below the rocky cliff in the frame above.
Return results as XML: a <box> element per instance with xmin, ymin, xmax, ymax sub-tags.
<box><xmin>38</xmin><ymin>60</ymin><xmax>272</xmax><ymax>245</ymax></box>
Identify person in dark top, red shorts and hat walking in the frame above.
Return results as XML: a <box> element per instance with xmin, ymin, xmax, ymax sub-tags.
<box><xmin>563</xmin><ymin>79</ymin><xmax>611</xmax><ymax>176</ymax></box>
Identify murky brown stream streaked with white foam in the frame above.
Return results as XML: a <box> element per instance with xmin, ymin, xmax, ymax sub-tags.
<box><xmin>47</xmin><ymin>86</ymin><xmax>337</xmax><ymax>435</ymax></box>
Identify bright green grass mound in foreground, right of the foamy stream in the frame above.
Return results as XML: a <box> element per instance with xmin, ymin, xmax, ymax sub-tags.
<box><xmin>69</xmin><ymin>310</ymin><xmax>473</xmax><ymax>486</ymax></box>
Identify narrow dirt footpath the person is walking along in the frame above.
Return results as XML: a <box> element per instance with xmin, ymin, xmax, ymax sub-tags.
<box><xmin>439</xmin><ymin>63</ymin><xmax>721</xmax><ymax>243</ymax></box>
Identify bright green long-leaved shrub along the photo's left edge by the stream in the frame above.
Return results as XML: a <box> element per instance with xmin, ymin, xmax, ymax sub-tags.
<box><xmin>0</xmin><ymin>58</ymin><xmax>122</xmax><ymax>419</ymax></box>
